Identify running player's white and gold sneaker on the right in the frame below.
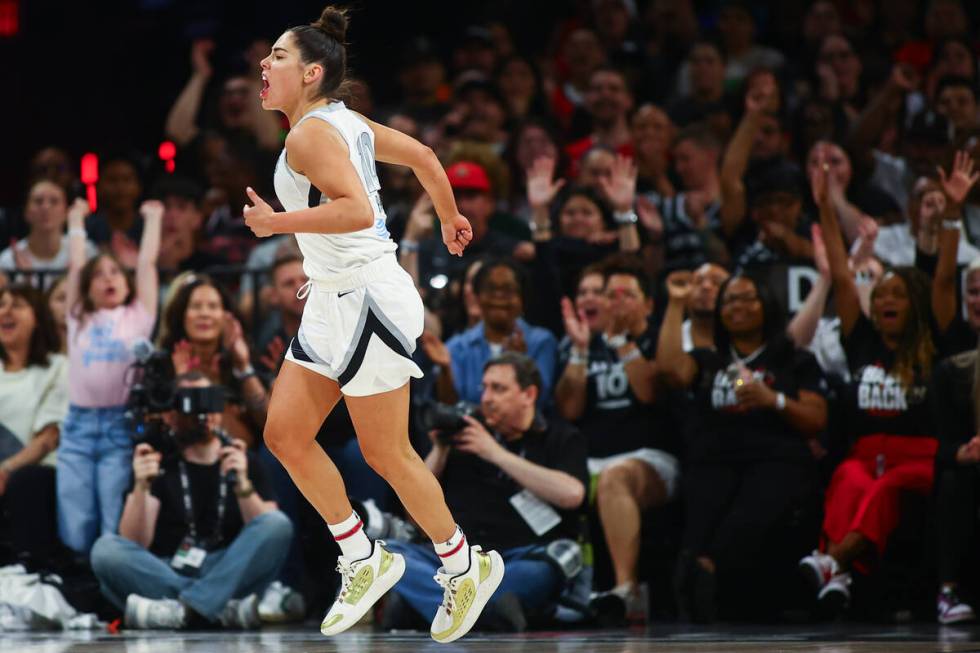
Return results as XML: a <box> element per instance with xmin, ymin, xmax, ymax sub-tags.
<box><xmin>430</xmin><ymin>546</ymin><xmax>504</xmax><ymax>644</ymax></box>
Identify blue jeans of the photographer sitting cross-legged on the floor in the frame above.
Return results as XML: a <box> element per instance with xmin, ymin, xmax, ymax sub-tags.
<box><xmin>92</xmin><ymin>510</ymin><xmax>293</xmax><ymax>621</ymax></box>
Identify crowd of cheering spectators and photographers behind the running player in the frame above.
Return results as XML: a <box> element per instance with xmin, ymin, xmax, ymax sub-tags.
<box><xmin>7</xmin><ymin>0</ymin><xmax>980</xmax><ymax>630</ymax></box>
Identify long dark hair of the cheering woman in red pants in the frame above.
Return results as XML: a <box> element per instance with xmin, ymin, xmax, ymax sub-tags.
<box><xmin>871</xmin><ymin>267</ymin><xmax>936</xmax><ymax>388</ymax></box>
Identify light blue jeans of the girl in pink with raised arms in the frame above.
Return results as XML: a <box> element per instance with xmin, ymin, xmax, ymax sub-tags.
<box><xmin>56</xmin><ymin>406</ymin><xmax>133</xmax><ymax>554</ymax></box>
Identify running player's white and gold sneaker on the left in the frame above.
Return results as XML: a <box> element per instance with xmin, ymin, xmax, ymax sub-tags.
<box><xmin>320</xmin><ymin>540</ymin><xmax>405</xmax><ymax>635</ymax></box>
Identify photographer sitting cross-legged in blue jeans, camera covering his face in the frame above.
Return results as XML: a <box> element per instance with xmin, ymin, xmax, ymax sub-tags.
<box><xmin>92</xmin><ymin>372</ymin><xmax>293</xmax><ymax>629</ymax></box>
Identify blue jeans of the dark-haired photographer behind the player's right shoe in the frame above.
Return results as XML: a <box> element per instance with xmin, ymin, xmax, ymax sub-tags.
<box><xmin>387</xmin><ymin>542</ymin><xmax>565</xmax><ymax>621</ymax></box>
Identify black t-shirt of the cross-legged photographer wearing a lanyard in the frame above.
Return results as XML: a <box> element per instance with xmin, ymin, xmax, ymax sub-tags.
<box><xmin>149</xmin><ymin>452</ymin><xmax>275</xmax><ymax>558</ymax></box>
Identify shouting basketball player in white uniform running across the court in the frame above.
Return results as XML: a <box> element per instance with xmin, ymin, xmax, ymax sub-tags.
<box><xmin>245</xmin><ymin>2</ymin><xmax>504</xmax><ymax>642</ymax></box>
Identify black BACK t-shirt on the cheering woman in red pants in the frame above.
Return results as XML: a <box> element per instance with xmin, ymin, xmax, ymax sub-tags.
<box><xmin>841</xmin><ymin>315</ymin><xmax>933</xmax><ymax>438</ymax></box>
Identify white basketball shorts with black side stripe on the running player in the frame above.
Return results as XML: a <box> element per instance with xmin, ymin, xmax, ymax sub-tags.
<box><xmin>286</xmin><ymin>254</ymin><xmax>424</xmax><ymax>397</ymax></box>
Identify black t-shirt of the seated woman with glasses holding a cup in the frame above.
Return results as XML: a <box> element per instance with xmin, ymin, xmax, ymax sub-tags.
<box><xmin>686</xmin><ymin>339</ymin><xmax>827</xmax><ymax>462</ymax></box>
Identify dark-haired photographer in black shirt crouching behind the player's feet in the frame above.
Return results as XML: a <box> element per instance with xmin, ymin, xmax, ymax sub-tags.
<box><xmin>390</xmin><ymin>352</ymin><xmax>588</xmax><ymax>629</ymax></box>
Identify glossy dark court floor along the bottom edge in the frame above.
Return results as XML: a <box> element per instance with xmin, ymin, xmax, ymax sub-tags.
<box><xmin>0</xmin><ymin>625</ymin><xmax>980</xmax><ymax>653</ymax></box>
